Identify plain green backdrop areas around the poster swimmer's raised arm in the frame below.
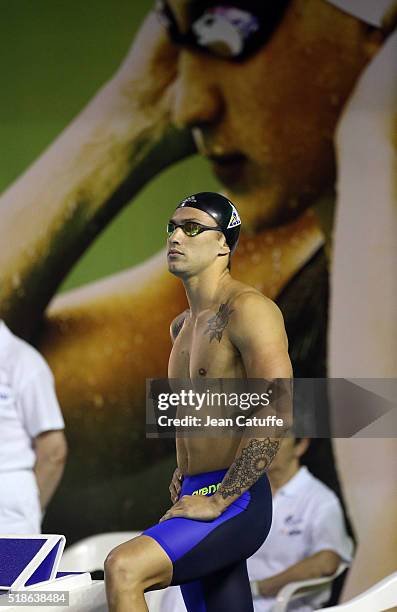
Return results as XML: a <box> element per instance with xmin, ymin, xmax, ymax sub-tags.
<box><xmin>0</xmin><ymin>0</ymin><xmax>219</xmax><ymax>291</ymax></box>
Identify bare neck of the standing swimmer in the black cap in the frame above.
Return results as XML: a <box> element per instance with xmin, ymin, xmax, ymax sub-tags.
<box><xmin>182</xmin><ymin>268</ymin><xmax>233</xmax><ymax>317</ymax></box>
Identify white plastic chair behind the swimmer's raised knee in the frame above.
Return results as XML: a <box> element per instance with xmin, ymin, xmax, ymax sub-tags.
<box><xmin>59</xmin><ymin>531</ymin><xmax>163</xmax><ymax>612</ymax></box>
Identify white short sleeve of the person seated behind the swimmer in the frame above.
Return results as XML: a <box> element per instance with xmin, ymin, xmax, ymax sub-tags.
<box><xmin>309</xmin><ymin>498</ymin><xmax>353</xmax><ymax>562</ymax></box>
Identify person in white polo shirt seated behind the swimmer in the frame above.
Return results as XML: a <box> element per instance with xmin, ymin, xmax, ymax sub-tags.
<box><xmin>161</xmin><ymin>437</ymin><xmax>353</xmax><ymax>612</ymax></box>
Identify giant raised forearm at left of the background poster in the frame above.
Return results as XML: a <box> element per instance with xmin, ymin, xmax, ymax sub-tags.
<box><xmin>0</xmin><ymin>14</ymin><xmax>193</xmax><ymax>338</ymax></box>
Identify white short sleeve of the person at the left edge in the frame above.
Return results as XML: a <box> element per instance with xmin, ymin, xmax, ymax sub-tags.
<box><xmin>18</xmin><ymin>364</ymin><xmax>65</xmax><ymax>438</ymax></box>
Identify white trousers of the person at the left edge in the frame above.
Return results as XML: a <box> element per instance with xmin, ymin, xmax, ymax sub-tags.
<box><xmin>0</xmin><ymin>470</ymin><xmax>41</xmax><ymax>535</ymax></box>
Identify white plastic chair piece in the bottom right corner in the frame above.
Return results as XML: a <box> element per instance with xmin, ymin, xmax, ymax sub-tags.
<box><xmin>321</xmin><ymin>572</ymin><xmax>397</xmax><ymax>612</ymax></box>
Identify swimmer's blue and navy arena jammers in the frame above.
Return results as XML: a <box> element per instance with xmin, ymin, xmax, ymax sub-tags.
<box><xmin>143</xmin><ymin>469</ymin><xmax>272</xmax><ymax>612</ymax></box>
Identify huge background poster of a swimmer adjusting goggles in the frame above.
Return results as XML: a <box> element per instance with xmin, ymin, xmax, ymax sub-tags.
<box><xmin>0</xmin><ymin>0</ymin><xmax>397</xmax><ymax>596</ymax></box>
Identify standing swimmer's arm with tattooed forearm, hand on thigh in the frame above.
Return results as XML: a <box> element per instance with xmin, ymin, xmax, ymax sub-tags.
<box><xmin>211</xmin><ymin>293</ymin><xmax>292</xmax><ymax>512</ymax></box>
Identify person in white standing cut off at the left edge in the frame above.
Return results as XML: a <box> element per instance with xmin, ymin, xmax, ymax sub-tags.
<box><xmin>0</xmin><ymin>320</ymin><xmax>67</xmax><ymax>535</ymax></box>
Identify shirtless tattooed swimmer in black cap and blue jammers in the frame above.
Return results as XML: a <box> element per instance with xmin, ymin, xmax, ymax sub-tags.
<box><xmin>105</xmin><ymin>192</ymin><xmax>292</xmax><ymax>612</ymax></box>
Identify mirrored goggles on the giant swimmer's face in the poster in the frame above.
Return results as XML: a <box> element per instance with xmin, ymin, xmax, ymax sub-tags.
<box><xmin>156</xmin><ymin>0</ymin><xmax>289</xmax><ymax>61</ymax></box>
